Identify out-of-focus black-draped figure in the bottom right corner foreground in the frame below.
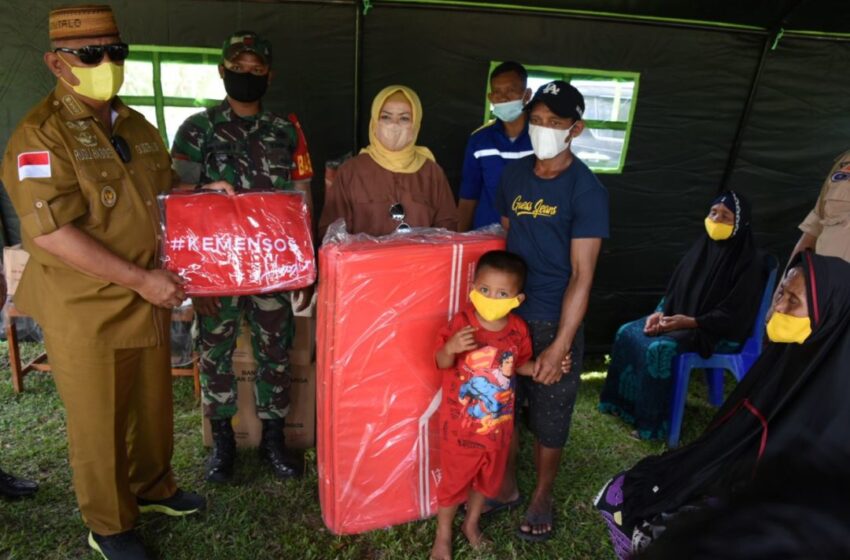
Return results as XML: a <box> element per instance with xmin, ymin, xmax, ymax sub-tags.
<box><xmin>637</xmin><ymin>448</ymin><xmax>850</xmax><ymax>560</ymax></box>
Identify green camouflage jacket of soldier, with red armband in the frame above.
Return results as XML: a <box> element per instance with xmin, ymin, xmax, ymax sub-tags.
<box><xmin>171</xmin><ymin>99</ymin><xmax>313</xmax><ymax>190</ymax></box>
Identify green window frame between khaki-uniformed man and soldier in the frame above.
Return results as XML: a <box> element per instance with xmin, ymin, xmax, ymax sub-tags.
<box><xmin>121</xmin><ymin>44</ymin><xmax>221</xmax><ymax>146</ymax></box>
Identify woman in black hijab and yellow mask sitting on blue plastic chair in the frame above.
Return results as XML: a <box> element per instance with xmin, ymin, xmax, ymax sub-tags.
<box><xmin>599</xmin><ymin>191</ymin><xmax>764</xmax><ymax>439</ymax></box>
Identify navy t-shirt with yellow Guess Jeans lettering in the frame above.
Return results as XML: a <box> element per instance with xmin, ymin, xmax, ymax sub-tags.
<box><xmin>496</xmin><ymin>156</ymin><xmax>608</xmax><ymax>322</ymax></box>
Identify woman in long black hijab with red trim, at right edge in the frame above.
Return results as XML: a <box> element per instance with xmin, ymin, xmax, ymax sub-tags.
<box><xmin>596</xmin><ymin>252</ymin><xmax>850</xmax><ymax>551</ymax></box>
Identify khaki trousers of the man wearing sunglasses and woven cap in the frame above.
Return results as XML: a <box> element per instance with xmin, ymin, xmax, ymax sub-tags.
<box><xmin>45</xmin><ymin>333</ymin><xmax>177</xmax><ymax>535</ymax></box>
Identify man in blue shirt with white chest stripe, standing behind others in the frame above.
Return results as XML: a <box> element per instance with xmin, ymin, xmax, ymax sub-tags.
<box><xmin>458</xmin><ymin>62</ymin><xmax>532</xmax><ymax>231</ymax></box>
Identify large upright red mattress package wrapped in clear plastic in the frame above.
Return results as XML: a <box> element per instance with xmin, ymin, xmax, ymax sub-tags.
<box><xmin>316</xmin><ymin>226</ymin><xmax>505</xmax><ymax>534</ymax></box>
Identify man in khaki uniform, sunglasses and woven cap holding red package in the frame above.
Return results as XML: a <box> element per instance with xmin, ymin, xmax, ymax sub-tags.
<box><xmin>2</xmin><ymin>5</ymin><xmax>232</xmax><ymax>560</ymax></box>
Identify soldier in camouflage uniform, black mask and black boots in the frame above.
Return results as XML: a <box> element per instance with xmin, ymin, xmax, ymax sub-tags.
<box><xmin>171</xmin><ymin>31</ymin><xmax>313</xmax><ymax>482</ymax></box>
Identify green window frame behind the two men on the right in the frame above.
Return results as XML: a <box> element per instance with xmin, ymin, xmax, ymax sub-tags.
<box><xmin>484</xmin><ymin>60</ymin><xmax>640</xmax><ymax>174</ymax></box>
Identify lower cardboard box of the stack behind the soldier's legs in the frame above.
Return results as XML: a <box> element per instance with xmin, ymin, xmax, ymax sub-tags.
<box><xmin>203</xmin><ymin>358</ymin><xmax>316</xmax><ymax>449</ymax></box>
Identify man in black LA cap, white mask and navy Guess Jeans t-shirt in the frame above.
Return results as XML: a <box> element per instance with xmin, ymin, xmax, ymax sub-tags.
<box><xmin>494</xmin><ymin>80</ymin><xmax>608</xmax><ymax>541</ymax></box>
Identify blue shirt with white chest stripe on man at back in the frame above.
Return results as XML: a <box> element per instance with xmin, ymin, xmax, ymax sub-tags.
<box><xmin>459</xmin><ymin>119</ymin><xmax>534</xmax><ymax>229</ymax></box>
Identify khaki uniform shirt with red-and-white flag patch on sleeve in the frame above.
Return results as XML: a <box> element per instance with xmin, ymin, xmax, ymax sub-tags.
<box><xmin>2</xmin><ymin>84</ymin><xmax>172</xmax><ymax>348</ymax></box>
